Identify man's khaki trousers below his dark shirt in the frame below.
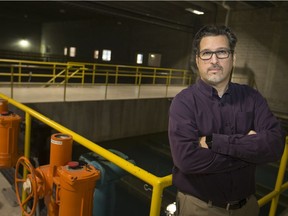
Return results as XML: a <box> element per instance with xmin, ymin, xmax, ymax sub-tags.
<box><xmin>176</xmin><ymin>192</ymin><xmax>259</xmax><ymax>216</ymax></box>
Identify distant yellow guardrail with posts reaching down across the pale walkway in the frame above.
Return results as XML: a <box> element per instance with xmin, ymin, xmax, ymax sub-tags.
<box><xmin>0</xmin><ymin>59</ymin><xmax>195</xmax><ymax>101</ymax></box>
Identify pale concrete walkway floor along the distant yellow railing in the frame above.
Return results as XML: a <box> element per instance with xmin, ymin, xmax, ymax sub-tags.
<box><xmin>0</xmin><ymin>85</ymin><xmax>186</xmax><ymax>103</ymax></box>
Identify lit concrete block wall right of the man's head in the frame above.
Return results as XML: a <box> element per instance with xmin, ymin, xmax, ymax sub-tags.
<box><xmin>229</xmin><ymin>8</ymin><xmax>288</xmax><ymax>114</ymax></box>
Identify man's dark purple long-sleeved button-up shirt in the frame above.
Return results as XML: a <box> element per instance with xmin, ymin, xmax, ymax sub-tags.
<box><xmin>169</xmin><ymin>80</ymin><xmax>285</xmax><ymax>202</ymax></box>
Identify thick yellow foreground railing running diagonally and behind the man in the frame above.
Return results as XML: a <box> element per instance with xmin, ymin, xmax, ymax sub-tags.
<box><xmin>0</xmin><ymin>93</ymin><xmax>288</xmax><ymax>216</ymax></box>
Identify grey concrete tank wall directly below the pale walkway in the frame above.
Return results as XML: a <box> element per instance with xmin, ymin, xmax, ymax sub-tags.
<box><xmin>26</xmin><ymin>99</ymin><xmax>170</xmax><ymax>143</ymax></box>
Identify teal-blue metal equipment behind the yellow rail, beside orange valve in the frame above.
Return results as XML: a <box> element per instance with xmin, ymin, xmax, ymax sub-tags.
<box><xmin>79</xmin><ymin>149</ymin><xmax>135</xmax><ymax>216</ymax></box>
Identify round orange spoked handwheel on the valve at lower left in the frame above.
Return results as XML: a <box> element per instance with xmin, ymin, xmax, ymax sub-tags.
<box><xmin>15</xmin><ymin>156</ymin><xmax>38</xmax><ymax>216</ymax></box>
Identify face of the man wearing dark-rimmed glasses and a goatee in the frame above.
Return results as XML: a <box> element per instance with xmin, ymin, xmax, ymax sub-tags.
<box><xmin>196</xmin><ymin>35</ymin><xmax>234</xmax><ymax>86</ymax></box>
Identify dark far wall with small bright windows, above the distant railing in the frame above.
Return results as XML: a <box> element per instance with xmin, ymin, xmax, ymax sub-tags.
<box><xmin>42</xmin><ymin>17</ymin><xmax>192</xmax><ymax>69</ymax></box>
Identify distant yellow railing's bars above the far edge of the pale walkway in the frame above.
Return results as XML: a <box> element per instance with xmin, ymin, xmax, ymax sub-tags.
<box><xmin>0</xmin><ymin>59</ymin><xmax>193</xmax><ymax>85</ymax></box>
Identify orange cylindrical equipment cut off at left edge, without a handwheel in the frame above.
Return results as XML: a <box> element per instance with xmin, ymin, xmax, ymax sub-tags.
<box><xmin>0</xmin><ymin>99</ymin><xmax>21</xmax><ymax>168</ymax></box>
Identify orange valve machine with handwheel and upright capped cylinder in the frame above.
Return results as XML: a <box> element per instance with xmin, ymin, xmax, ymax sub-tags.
<box><xmin>15</xmin><ymin>133</ymin><xmax>100</xmax><ymax>216</ymax></box>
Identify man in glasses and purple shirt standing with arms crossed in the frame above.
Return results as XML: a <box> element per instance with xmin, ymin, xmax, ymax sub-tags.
<box><xmin>169</xmin><ymin>26</ymin><xmax>284</xmax><ymax>216</ymax></box>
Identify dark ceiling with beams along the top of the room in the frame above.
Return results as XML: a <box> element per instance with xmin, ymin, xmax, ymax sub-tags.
<box><xmin>0</xmin><ymin>1</ymin><xmax>287</xmax><ymax>28</ymax></box>
